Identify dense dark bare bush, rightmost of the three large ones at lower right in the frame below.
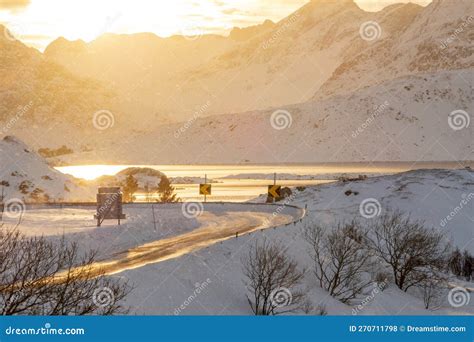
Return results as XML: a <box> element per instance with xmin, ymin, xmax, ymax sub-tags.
<box><xmin>367</xmin><ymin>211</ymin><xmax>449</xmax><ymax>291</ymax></box>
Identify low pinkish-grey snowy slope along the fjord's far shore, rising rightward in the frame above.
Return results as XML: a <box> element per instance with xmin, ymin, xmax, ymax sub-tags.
<box><xmin>56</xmin><ymin>69</ymin><xmax>474</xmax><ymax>164</ymax></box>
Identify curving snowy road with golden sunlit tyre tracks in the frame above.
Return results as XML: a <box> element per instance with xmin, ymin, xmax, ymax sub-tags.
<box><xmin>85</xmin><ymin>205</ymin><xmax>305</xmax><ymax>275</ymax></box>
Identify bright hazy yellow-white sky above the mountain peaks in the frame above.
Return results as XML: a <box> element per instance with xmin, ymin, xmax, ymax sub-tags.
<box><xmin>0</xmin><ymin>0</ymin><xmax>431</xmax><ymax>49</ymax></box>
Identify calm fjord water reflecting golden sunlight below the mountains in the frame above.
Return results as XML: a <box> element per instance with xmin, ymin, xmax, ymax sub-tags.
<box><xmin>56</xmin><ymin>162</ymin><xmax>474</xmax><ymax>202</ymax></box>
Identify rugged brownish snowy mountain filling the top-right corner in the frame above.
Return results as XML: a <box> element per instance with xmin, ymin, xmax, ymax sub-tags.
<box><xmin>315</xmin><ymin>0</ymin><xmax>474</xmax><ymax>98</ymax></box>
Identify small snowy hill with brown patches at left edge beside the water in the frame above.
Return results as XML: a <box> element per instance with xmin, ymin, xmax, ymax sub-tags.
<box><xmin>0</xmin><ymin>136</ymin><xmax>93</xmax><ymax>202</ymax></box>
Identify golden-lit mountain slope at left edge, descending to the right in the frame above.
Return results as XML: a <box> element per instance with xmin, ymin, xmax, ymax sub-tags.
<box><xmin>0</xmin><ymin>26</ymin><xmax>121</xmax><ymax>132</ymax></box>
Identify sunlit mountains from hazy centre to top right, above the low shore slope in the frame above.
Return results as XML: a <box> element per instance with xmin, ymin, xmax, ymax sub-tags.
<box><xmin>39</xmin><ymin>0</ymin><xmax>474</xmax><ymax>121</ymax></box>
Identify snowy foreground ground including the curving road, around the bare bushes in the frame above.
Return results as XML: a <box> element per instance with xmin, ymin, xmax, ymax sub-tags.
<box><xmin>4</xmin><ymin>169</ymin><xmax>474</xmax><ymax>315</ymax></box>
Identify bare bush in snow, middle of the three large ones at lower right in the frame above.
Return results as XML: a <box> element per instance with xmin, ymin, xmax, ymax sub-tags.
<box><xmin>305</xmin><ymin>222</ymin><xmax>372</xmax><ymax>303</ymax></box>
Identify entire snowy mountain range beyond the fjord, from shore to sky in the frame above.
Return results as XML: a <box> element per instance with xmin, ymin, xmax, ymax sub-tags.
<box><xmin>0</xmin><ymin>0</ymin><xmax>474</xmax><ymax>163</ymax></box>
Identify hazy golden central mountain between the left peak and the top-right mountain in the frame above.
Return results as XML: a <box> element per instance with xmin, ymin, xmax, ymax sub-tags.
<box><xmin>41</xmin><ymin>0</ymin><xmax>366</xmax><ymax>121</ymax></box>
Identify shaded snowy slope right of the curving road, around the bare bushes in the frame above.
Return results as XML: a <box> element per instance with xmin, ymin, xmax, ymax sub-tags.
<box><xmin>117</xmin><ymin>170</ymin><xmax>474</xmax><ymax>315</ymax></box>
